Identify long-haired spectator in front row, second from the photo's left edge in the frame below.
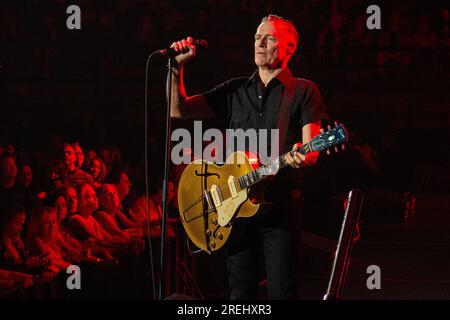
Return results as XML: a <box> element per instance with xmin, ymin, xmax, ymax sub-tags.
<box><xmin>26</xmin><ymin>207</ymin><xmax>71</xmax><ymax>273</ymax></box>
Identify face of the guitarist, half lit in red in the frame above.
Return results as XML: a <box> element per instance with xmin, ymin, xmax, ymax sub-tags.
<box><xmin>255</xmin><ymin>21</ymin><xmax>290</xmax><ymax>69</ymax></box>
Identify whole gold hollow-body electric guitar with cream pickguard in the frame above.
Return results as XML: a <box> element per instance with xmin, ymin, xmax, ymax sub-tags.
<box><xmin>178</xmin><ymin>124</ymin><xmax>347</xmax><ymax>253</ymax></box>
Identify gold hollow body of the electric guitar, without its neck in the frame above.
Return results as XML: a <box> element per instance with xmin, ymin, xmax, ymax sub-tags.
<box><xmin>178</xmin><ymin>151</ymin><xmax>259</xmax><ymax>252</ymax></box>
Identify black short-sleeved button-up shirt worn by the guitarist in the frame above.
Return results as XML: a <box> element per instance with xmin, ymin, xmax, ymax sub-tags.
<box><xmin>204</xmin><ymin>68</ymin><xmax>328</xmax><ymax>198</ymax></box>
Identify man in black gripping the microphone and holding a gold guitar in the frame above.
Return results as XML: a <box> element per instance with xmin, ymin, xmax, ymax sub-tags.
<box><xmin>167</xmin><ymin>15</ymin><xmax>328</xmax><ymax>299</ymax></box>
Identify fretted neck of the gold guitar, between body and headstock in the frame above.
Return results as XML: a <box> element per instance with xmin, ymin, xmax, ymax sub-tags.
<box><xmin>239</xmin><ymin>143</ymin><xmax>312</xmax><ymax>190</ymax></box>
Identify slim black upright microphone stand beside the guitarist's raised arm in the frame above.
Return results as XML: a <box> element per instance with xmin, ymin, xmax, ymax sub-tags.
<box><xmin>159</xmin><ymin>56</ymin><xmax>173</xmax><ymax>300</ymax></box>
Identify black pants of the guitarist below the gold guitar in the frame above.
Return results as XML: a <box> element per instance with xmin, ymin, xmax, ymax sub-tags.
<box><xmin>227</xmin><ymin>202</ymin><xmax>300</xmax><ymax>300</ymax></box>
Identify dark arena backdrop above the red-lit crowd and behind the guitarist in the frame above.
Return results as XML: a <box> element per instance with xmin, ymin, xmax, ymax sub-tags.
<box><xmin>0</xmin><ymin>0</ymin><xmax>450</xmax><ymax>300</ymax></box>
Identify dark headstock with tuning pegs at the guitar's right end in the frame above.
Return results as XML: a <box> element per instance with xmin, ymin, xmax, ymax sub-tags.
<box><xmin>309</xmin><ymin>122</ymin><xmax>348</xmax><ymax>154</ymax></box>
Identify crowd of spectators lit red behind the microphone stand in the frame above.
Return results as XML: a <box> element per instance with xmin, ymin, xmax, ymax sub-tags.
<box><xmin>0</xmin><ymin>143</ymin><xmax>175</xmax><ymax>293</ymax></box>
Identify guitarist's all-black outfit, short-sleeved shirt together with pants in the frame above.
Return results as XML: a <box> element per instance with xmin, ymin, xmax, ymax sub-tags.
<box><xmin>204</xmin><ymin>68</ymin><xmax>328</xmax><ymax>299</ymax></box>
